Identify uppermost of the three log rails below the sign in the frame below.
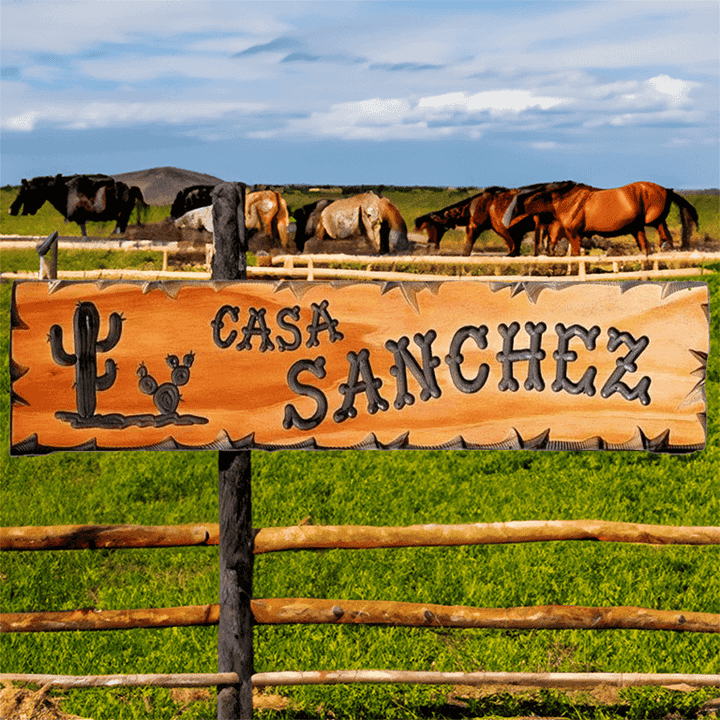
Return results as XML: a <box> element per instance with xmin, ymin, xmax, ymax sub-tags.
<box><xmin>5</xmin><ymin>520</ymin><xmax>720</xmax><ymax>554</ymax></box>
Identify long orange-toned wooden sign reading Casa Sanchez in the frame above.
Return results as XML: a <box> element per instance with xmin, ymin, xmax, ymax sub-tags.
<box><xmin>11</xmin><ymin>281</ymin><xmax>709</xmax><ymax>454</ymax></box>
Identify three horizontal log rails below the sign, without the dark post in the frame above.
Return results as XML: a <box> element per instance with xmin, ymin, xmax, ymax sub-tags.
<box><xmin>0</xmin><ymin>520</ymin><xmax>720</xmax><ymax>704</ymax></box>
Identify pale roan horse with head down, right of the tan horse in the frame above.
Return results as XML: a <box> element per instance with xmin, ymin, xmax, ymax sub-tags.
<box><xmin>305</xmin><ymin>192</ymin><xmax>410</xmax><ymax>254</ymax></box>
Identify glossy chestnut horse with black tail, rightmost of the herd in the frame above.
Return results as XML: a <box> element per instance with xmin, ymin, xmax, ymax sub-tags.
<box><xmin>504</xmin><ymin>181</ymin><xmax>699</xmax><ymax>255</ymax></box>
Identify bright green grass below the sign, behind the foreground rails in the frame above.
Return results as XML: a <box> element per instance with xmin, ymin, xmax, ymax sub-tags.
<box><xmin>0</xmin><ymin>197</ymin><xmax>720</xmax><ymax>720</ymax></box>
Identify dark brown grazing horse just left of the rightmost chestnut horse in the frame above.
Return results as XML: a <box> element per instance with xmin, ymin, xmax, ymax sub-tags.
<box><xmin>415</xmin><ymin>187</ymin><xmax>562</xmax><ymax>257</ymax></box>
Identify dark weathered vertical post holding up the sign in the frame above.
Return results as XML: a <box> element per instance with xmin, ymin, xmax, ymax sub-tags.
<box><xmin>212</xmin><ymin>183</ymin><xmax>254</xmax><ymax>720</ymax></box>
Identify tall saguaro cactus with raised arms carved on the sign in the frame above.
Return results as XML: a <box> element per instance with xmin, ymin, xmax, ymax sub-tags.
<box><xmin>48</xmin><ymin>302</ymin><xmax>124</xmax><ymax>419</ymax></box>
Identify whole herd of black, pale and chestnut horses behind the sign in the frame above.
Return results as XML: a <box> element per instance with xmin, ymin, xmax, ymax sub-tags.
<box><xmin>9</xmin><ymin>175</ymin><xmax>698</xmax><ymax>256</ymax></box>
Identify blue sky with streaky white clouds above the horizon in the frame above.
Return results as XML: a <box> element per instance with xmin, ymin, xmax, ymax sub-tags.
<box><xmin>0</xmin><ymin>0</ymin><xmax>720</xmax><ymax>188</ymax></box>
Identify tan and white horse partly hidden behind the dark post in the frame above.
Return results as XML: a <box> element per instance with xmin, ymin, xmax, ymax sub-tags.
<box><xmin>175</xmin><ymin>190</ymin><xmax>290</xmax><ymax>250</ymax></box>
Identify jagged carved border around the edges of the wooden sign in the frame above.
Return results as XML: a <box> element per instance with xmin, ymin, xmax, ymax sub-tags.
<box><xmin>10</xmin><ymin>279</ymin><xmax>710</xmax><ymax>455</ymax></box>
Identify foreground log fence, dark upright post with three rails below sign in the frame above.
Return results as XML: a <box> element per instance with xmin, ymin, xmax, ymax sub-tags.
<box><xmin>0</xmin><ymin>183</ymin><xmax>720</xmax><ymax>719</ymax></box>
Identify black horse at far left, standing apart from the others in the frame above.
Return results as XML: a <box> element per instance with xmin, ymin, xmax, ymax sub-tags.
<box><xmin>8</xmin><ymin>175</ymin><xmax>147</xmax><ymax>237</ymax></box>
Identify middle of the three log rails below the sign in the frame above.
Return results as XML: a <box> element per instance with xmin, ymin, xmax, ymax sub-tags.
<box><xmin>0</xmin><ymin>598</ymin><xmax>720</xmax><ymax>633</ymax></box>
